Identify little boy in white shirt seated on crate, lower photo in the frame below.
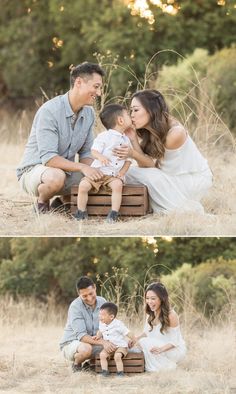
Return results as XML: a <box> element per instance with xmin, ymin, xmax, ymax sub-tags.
<box><xmin>93</xmin><ymin>302</ymin><xmax>134</xmax><ymax>377</ymax></box>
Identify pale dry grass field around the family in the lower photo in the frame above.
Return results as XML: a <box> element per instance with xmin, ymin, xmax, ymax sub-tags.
<box><xmin>0</xmin><ymin>299</ymin><xmax>236</xmax><ymax>394</ymax></box>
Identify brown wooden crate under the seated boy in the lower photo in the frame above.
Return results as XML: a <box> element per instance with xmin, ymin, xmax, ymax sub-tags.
<box><xmin>94</xmin><ymin>352</ymin><xmax>144</xmax><ymax>373</ymax></box>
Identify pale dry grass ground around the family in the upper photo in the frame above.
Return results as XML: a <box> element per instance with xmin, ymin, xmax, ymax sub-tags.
<box><xmin>0</xmin><ymin>143</ymin><xmax>236</xmax><ymax>236</ymax></box>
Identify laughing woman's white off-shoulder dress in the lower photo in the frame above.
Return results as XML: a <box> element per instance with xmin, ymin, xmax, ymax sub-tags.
<box><xmin>139</xmin><ymin>321</ymin><xmax>186</xmax><ymax>372</ymax></box>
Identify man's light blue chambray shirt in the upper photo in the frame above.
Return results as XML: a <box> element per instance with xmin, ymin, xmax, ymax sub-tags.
<box><xmin>16</xmin><ymin>92</ymin><xmax>95</xmax><ymax>179</ymax></box>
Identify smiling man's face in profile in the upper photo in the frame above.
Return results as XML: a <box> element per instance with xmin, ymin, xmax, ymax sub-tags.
<box><xmin>75</xmin><ymin>73</ymin><xmax>102</xmax><ymax>105</ymax></box>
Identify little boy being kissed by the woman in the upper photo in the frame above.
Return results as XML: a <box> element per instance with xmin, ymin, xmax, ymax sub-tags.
<box><xmin>74</xmin><ymin>104</ymin><xmax>132</xmax><ymax>223</ymax></box>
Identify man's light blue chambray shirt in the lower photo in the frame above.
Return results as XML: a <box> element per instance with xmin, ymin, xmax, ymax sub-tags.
<box><xmin>60</xmin><ymin>296</ymin><xmax>106</xmax><ymax>349</ymax></box>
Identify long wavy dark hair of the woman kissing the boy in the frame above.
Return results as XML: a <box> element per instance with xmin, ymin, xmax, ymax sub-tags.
<box><xmin>131</xmin><ymin>89</ymin><xmax>170</xmax><ymax>168</ymax></box>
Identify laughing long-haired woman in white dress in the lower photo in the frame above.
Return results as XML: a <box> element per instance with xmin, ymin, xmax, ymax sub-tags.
<box><xmin>136</xmin><ymin>282</ymin><xmax>186</xmax><ymax>372</ymax></box>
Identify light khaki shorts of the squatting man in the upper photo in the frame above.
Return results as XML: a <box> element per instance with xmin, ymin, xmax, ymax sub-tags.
<box><xmin>19</xmin><ymin>164</ymin><xmax>83</xmax><ymax>197</ymax></box>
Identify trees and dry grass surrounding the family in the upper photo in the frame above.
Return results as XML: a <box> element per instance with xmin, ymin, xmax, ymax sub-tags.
<box><xmin>0</xmin><ymin>0</ymin><xmax>236</xmax><ymax>236</ymax></box>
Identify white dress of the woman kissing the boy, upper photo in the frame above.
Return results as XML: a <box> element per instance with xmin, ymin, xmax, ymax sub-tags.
<box><xmin>126</xmin><ymin>135</ymin><xmax>212</xmax><ymax>213</ymax></box>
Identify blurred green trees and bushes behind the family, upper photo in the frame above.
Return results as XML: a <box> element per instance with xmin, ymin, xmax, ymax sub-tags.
<box><xmin>0</xmin><ymin>0</ymin><xmax>236</xmax><ymax>139</ymax></box>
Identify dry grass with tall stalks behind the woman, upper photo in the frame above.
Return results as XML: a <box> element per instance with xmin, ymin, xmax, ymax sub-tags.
<box><xmin>0</xmin><ymin>58</ymin><xmax>236</xmax><ymax>236</ymax></box>
